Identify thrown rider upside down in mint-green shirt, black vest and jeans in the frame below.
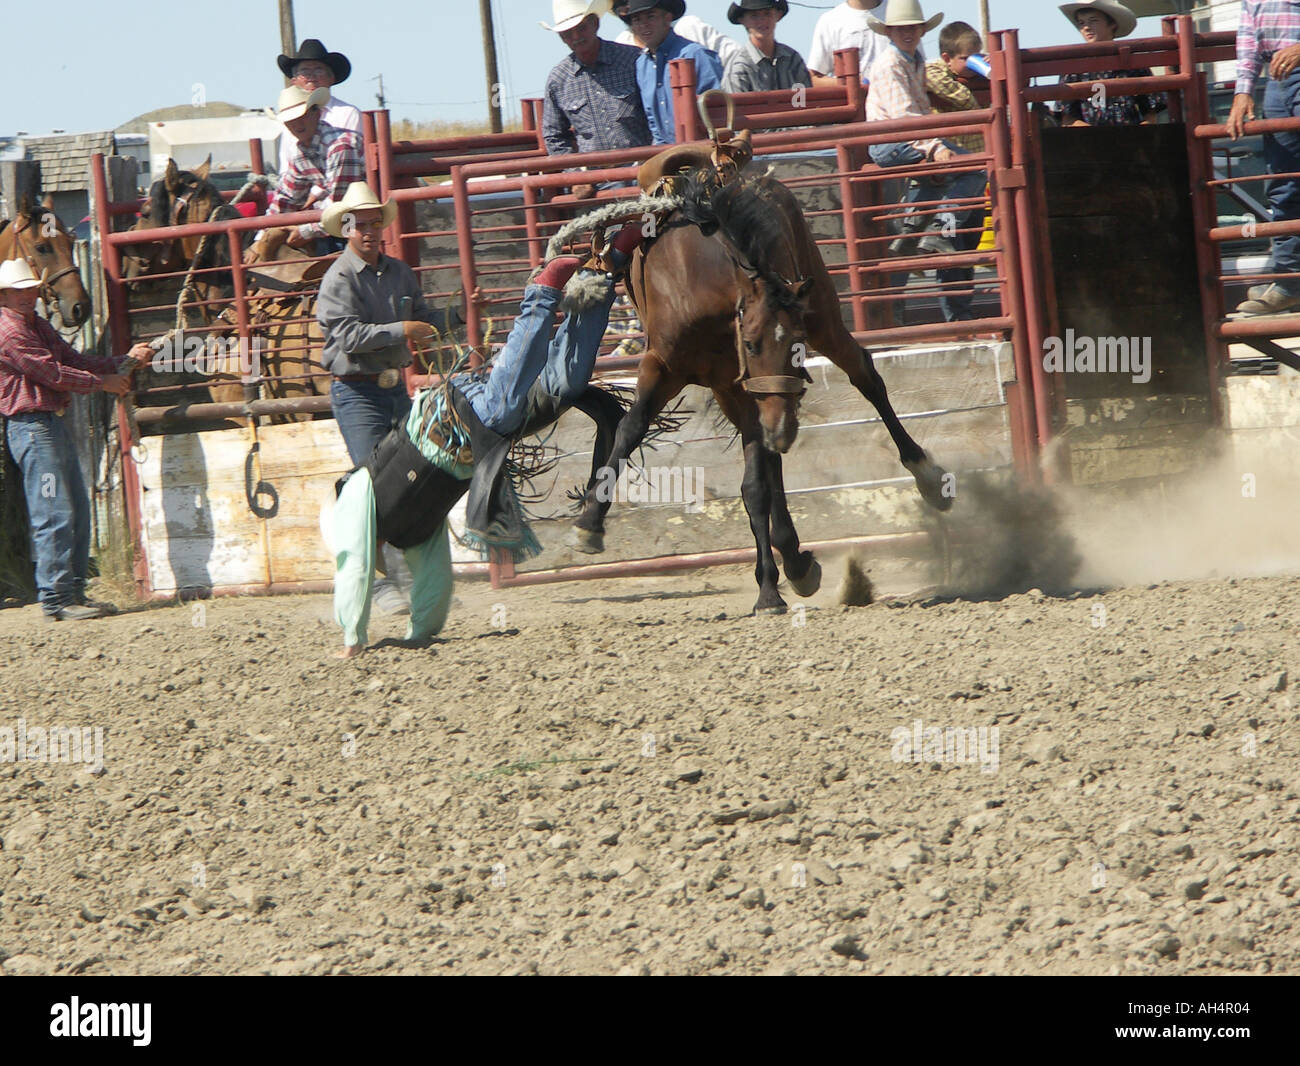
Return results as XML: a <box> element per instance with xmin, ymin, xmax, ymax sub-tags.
<box><xmin>321</xmin><ymin>191</ymin><xmax>642</xmax><ymax>659</ymax></box>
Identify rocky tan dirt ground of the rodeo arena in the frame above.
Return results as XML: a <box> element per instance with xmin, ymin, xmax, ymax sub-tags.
<box><xmin>0</xmin><ymin>564</ymin><xmax>1300</xmax><ymax>974</ymax></box>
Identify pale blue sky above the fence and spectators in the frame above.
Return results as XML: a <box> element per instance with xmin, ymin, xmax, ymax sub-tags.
<box><xmin>0</xmin><ymin>0</ymin><xmax>1190</xmax><ymax>134</ymax></box>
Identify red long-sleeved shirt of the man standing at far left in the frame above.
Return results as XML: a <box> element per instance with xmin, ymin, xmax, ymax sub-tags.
<box><xmin>0</xmin><ymin>308</ymin><xmax>117</xmax><ymax>417</ymax></box>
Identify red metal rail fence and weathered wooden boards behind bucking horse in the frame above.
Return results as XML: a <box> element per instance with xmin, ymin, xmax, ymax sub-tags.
<box><xmin>76</xmin><ymin>17</ymin><xmax>1300</xmax><ymax>598</ymax></box>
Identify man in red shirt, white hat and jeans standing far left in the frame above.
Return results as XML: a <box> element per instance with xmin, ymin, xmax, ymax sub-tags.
<box><xmin>0</xmin><ymin>259</ymin><xmax>153</xmax><ymax>621</ymax></box>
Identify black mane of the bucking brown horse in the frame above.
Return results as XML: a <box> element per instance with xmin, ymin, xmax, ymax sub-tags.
<box><xmin>679</xmin><ymin>168</ymin><xmax>798</xmax><ymax>309</ymax></box>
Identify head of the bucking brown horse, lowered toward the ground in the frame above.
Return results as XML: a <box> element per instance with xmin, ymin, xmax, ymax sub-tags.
<box><xmin>736</xmin><ymin>264</ymin><xmax>813</xmax><ymax>455</ymax></box>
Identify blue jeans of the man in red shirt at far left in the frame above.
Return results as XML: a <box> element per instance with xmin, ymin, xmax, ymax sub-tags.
<box><xmin>5</xmin><ymin>412</ymin><xmax>90</xmax><ymax>615</ymax></box>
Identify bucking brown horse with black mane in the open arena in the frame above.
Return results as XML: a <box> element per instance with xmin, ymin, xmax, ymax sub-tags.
<box><xmin>575</xmin><ymin>159</ymin><xmax>952</xmax><ymax>614</ymax></box>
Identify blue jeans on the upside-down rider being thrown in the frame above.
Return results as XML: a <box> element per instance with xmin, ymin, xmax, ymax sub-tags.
<box><xmin>455</xmin><ymin>285</ymin><xmax>614</xmax><ymax>437</ymax></box>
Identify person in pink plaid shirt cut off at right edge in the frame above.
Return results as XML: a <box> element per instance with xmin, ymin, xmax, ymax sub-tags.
<box><xmin>1227</xmin><ymin>0</ymin><xmax>1300</xmax><ymax>317</ymax></box>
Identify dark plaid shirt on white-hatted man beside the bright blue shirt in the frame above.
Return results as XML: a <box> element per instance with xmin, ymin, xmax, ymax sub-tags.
<box><xmin>542</xmin><ymin>40</ymin><xmax>650</xmax><ymax>156</ymax></box>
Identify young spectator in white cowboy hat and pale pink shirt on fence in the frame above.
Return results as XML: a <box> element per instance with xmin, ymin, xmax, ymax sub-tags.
<box><xmin>867</xmin><ymin>0</ymin><xmax>985</xmax><ymax>322</ymax></box>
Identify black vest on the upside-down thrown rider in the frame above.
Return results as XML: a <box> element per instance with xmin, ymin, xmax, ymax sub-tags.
<box><xmin>361</xmin><ymin>426</ymin><xmax>469</xmax><ymax>547</ymax></box>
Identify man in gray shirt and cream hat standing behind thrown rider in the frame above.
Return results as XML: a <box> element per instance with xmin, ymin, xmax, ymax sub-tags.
<box><xmin>316</xmin><ymin>182</ymin><xmax>437</xmax><ymax>614</ymax></box>
